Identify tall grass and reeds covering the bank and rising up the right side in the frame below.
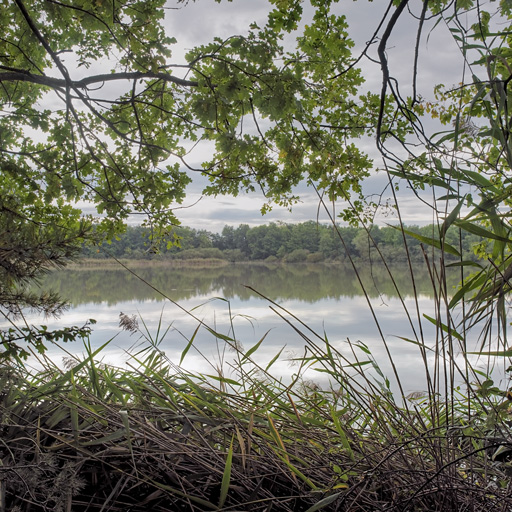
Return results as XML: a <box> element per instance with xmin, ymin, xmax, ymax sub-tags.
<box><xmin>0</xmin><ymin>4</ymin><xmax>512</xmax><ymax>512</ymax></box>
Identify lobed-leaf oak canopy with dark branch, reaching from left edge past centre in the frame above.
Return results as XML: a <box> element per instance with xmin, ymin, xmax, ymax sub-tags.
<box><xmin>0</xmin><ymin>0</ymin><xmax>382</xmax><ymax>356</ymax></box>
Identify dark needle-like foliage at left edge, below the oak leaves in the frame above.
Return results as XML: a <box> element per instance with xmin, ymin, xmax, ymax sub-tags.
<box><xmin>0</xmin><ymin>198</ymin><xmax>91</xmax><ymax>359</ymax></box>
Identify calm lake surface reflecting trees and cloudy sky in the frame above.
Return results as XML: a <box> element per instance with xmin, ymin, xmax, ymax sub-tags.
<box><xmin>21</xmin><ymin>264</ymin><xmax>496</xmax><ymax>392</ymax></box>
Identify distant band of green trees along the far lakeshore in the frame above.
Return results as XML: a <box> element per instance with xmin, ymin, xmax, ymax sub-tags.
<box><xmin>82</xmin><ymin>221</ymin><xmax>483</xmax><ymax>263</ymax></box>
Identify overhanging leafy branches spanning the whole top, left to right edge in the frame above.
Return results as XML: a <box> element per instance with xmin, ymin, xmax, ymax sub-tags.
<box><xmin>4</xmin><ymin>0</ymin><xmax>512</xmax><ymax>358</ymax></box>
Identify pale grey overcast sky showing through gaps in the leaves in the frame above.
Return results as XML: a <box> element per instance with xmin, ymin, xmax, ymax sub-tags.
<box><xmin>152</xmin><ymin>0</ymin><xmax>462</xmax><ymax>231</ymax></box>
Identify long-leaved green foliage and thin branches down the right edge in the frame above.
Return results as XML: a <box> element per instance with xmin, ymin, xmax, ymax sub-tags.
<box><xmin>370</xmin><ymin>1</ymin><xmax>512</xmax><ymax>346</ymax></box>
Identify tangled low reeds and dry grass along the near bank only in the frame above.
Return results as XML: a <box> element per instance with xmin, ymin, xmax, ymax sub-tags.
<box><xmin>0</xmin><ymin>310</ymin><xmax>512</xmax><ymax>512</ymax></box>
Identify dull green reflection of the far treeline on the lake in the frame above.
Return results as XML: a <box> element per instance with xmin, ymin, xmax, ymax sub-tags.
<box><xmin>42</xmin><ymin>264</ymin><xmax>459</xmax><ymax>306</ymax></box>
